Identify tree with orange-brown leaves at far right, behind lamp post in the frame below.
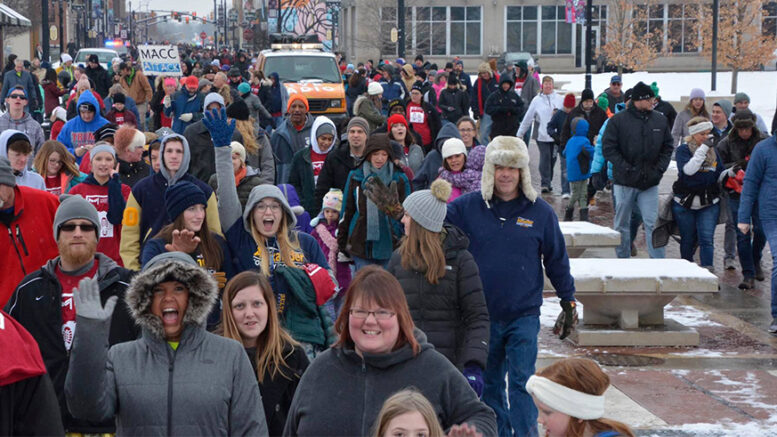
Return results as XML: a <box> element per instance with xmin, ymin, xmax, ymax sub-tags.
<box><xmin>700</xmin><ymin>0</ymin><xmax>777</xmax><ymax>94</ymax></box>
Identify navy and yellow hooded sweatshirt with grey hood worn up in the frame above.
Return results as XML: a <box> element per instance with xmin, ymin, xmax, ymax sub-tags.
<box><xmin>120</xmin><ymin>134</ymin><xmax>222</xmax><ymax>270</ymax></box>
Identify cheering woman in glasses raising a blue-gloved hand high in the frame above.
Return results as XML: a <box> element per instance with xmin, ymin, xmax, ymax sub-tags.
<box><xmin>209</xmin><ymin>109</ymin><xmax>335</xmax><ymax>359</ymax></box>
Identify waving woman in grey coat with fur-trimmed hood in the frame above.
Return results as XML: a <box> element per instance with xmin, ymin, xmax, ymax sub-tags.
<box><xmin>65</xmin><ymin>252</ymin><xmax>267</xmax><ymax>436</ymax></box>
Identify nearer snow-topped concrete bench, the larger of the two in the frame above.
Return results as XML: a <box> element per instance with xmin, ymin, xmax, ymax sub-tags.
<box><xmin>544</xmin><ymin>258</ymin><xmax>718</xmax><ymax>346</ymax></box>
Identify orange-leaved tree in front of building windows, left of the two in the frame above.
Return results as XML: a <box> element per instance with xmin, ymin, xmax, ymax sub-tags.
<box><xmin>601</xmin><ymin>0</ymin><xmax>672</xmax><ymax>74</ymax></box>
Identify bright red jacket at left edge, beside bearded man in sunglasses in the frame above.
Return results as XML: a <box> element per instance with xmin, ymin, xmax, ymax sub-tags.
<box><xmin>0</xmin><ymin>186</ymin><xmax>59</xmax><ymax>307</ymax></box>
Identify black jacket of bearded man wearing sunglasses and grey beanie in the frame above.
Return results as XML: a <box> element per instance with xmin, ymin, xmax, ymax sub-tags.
<box><xmin>6</xmin><ymin>254</ymin><xmax>140</xmax><ymax>434</ymax></box>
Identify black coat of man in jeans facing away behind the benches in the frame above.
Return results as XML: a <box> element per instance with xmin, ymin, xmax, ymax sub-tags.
<box><xmin>600</xmin><ymin>104</ymin><xmax>674</xmax><ymax>190</ymax></box>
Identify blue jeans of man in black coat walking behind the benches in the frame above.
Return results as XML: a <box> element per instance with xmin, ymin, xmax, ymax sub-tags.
<box><xmin>613</xmin><ymin>184</ymin><xmax>665</xmax><ymax>258</ymax></box>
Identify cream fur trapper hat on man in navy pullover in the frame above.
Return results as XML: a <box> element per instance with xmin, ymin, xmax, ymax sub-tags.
<box><xmin>480</xmin><ymin>136</ymin><xmax>537</xmax><ymax>202</ymax></box>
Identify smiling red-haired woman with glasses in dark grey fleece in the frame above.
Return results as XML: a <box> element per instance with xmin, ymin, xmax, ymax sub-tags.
<box><xmin>284</xmin><ymin>266</ymin><xmax>497</xmax><ymax>436</ymax></box>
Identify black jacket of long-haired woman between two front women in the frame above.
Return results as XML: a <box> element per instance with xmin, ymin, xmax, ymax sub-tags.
<box><xmin>246</xmin><ymin>345</ymin><xmax>310</xmax><ymax>436</ymax></box>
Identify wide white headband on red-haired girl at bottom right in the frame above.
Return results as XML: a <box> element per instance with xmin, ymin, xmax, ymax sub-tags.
<box><xmin>526</xmin><ymin>375</ymin><xmax>604</xmax><ymax>420</ymax></box>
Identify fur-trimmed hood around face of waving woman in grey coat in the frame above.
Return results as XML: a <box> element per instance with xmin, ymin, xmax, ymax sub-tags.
<box><xmin>126</xmin><ymin>255</ymin><xmax>218</xmax><ymax>339</ymax></box>
